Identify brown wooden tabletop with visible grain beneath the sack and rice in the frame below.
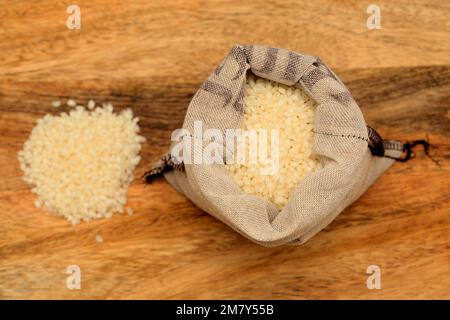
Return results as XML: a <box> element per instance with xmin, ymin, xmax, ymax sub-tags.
<box><xmin>0</xmin><ymin>0</ymin><xmax>450</xmax><ymax>299</ymax></box>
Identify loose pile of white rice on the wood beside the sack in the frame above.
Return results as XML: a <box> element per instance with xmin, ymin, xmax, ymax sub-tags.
<box><xmin>18</xmin><ymin>100</ymin><xmax>145</xmax><ymax>224</ymax></box>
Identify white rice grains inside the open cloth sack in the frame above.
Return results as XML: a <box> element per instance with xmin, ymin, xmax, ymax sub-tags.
<box><xmin>227</xmin><ymin>76</ymin><xmax>322</xmax><ymax>210</ymax></box>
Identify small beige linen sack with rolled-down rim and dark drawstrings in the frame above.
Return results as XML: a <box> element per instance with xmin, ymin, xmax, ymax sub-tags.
<box><xmin>147</xmin><ymin>45</ymin><xmax>403</xmax><ymax>246</ymax></box>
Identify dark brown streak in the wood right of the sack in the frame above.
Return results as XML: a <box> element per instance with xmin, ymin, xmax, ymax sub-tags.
<box><xmin>341</xmin><ymin>66</ymin><xmax>450</xmax><ymax>137</ymax></box>
